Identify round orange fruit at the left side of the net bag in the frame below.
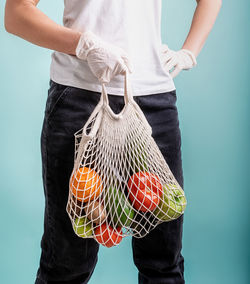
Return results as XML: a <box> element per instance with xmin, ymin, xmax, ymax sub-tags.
<box><xmin>70</xmin><ymin>167</ymin><xmax>102</xmax><ymax>202</ymax></box>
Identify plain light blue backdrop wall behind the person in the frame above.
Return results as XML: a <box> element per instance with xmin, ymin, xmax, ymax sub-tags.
<box><xmin>0</xmin><ymin>0</ymin><xmax>250</xmax><ymax>284</ymax></box>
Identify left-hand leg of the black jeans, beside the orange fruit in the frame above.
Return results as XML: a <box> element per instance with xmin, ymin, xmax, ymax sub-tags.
<box><xmin>38</xmin><ymin>81</ymin><xmax>100</xmax><ymax>283</ymax></box>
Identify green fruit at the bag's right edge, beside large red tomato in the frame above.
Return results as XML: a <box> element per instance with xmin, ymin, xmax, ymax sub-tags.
<box><xmin>153</xmin><ymin>184</ymin><xmax>187</xmax><ymax>221</ymax></box>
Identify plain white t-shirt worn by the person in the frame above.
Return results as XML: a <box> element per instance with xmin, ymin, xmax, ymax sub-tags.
<box><xmin>50</xmin><ymin>0</ymin><xmax>175</xmax><ymax>96</ymax></box>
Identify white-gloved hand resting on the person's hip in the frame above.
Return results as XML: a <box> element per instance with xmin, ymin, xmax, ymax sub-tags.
<box><xmin>161</xmin><ymin>44</ymin><xmax>197</xmax><ymax>78</ymax></box>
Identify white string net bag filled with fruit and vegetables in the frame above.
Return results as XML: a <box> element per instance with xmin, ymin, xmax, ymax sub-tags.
<box><xmin>66</xmin><ymin>71</ymin><xmax>186</xmax><ymax>247</ymax></box>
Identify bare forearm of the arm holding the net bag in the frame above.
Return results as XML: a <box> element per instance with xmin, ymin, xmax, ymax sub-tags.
<box><xmin>5</xmin><ymin>0</ymin><xmax>81</xmax><ymax>55</ymax></box>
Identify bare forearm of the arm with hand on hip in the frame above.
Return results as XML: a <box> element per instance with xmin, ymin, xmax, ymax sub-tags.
<box><xmin>182</xmin><ymin>0</ymin><xmax>221</xmax><ymax>56</ymax></box>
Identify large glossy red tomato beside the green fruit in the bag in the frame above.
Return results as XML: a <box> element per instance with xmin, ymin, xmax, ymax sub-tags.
<box><xmin>128</xmin><ymin>172</ymin><xmax>163</xmax><ymax>212</ymax></box>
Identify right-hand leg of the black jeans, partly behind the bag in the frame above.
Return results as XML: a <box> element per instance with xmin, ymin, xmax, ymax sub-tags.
<box><xmin>132</xmin><ymin>91</ymin><xmax>184</xmax><ymax>284</ymax></box>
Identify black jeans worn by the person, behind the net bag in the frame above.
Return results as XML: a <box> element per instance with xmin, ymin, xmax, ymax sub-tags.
<box><xmin>35</xmin><ymin>80</ymin><xmax>185</xmax><ymax>284</ymax></box>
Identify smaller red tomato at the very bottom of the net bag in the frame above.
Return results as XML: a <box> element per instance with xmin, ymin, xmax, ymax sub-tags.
<box><xmin>95</xmin><ymin>223</ymin><xmax>122</xmax><ymax>248</ymax></box>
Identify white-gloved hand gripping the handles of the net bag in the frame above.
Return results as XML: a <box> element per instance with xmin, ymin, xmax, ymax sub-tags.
<box><xmin>76</xmin><ymin>31</ymin><xmax>132</xmax><ymax>83</ymax></box>
